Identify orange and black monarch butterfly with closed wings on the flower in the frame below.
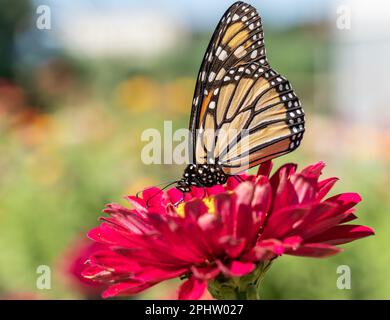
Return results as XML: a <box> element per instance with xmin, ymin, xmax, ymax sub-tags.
<box><xmin>176</xmin><ymin>2</ymin><xmax>305</xmax><ymax>193</ymax></box>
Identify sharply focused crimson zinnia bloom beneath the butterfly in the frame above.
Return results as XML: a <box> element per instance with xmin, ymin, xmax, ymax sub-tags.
<box><xmin>83</xmin><ymin>162</ymin><xmax>373</xmax><ymax>299</ymax></box>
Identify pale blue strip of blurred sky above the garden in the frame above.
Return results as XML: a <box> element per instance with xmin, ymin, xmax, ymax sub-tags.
<box><xmin>35</xmin><ymin>0</ymin><xmax>330</xmax><ymax>29</ymax></box>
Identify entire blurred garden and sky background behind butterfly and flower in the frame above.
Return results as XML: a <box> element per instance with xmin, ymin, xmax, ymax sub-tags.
<box><xmin>0</xmin><ymin>0</ymin><xmax>390</xmax><ymax>299</ymax></box>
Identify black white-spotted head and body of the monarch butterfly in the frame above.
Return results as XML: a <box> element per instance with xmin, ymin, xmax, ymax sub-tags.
<box><xmin>176</xmin><ymin>164</ymin><xmax>228</xmax><ymax>193</ymax></box>
